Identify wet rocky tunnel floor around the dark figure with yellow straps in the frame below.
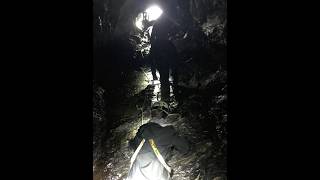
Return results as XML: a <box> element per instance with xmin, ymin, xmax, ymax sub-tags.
<box><xmin>93</xmin><ymin>68</ymin><xmax>227</xmax><ymax>180</ymax></box>
